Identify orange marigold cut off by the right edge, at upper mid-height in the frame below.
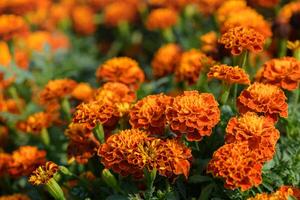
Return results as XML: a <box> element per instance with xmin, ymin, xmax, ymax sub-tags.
<box><xmin>259</xmin><ymin>57</ymin><xmax>300</xmax><ymax>90</ymax></box>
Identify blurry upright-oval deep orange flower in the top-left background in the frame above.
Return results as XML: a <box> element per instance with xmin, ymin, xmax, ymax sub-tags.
<box><xmin>72</xmin><ymin>6</ymin><xmax>96</xmax><ymax>35</ymax></box>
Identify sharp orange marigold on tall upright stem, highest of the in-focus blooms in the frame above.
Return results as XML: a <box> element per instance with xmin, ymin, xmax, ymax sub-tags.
<box><xmin>219</xmin><ymin>26</ymin><xmax>265</xmax><ymax>55</ymax></box>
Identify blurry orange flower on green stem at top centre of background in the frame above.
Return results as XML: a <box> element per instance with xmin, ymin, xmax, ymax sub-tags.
<box><xmin>146</xmin><ymin>8</ymin><xmax>178</xmax><ymax>30</ymax></box>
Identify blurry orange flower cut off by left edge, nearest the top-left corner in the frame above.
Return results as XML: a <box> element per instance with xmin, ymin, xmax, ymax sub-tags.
<box><xmin>0</xmin><ymin>15</ymin><xmax>28</xmax><ymax>40</ymax></box>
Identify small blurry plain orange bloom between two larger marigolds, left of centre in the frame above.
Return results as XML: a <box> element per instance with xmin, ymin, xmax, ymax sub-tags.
<box><xmin>71</xmin><ymin>83</ymin><xmax>94</xmax><ymax>102</ymax></box>
